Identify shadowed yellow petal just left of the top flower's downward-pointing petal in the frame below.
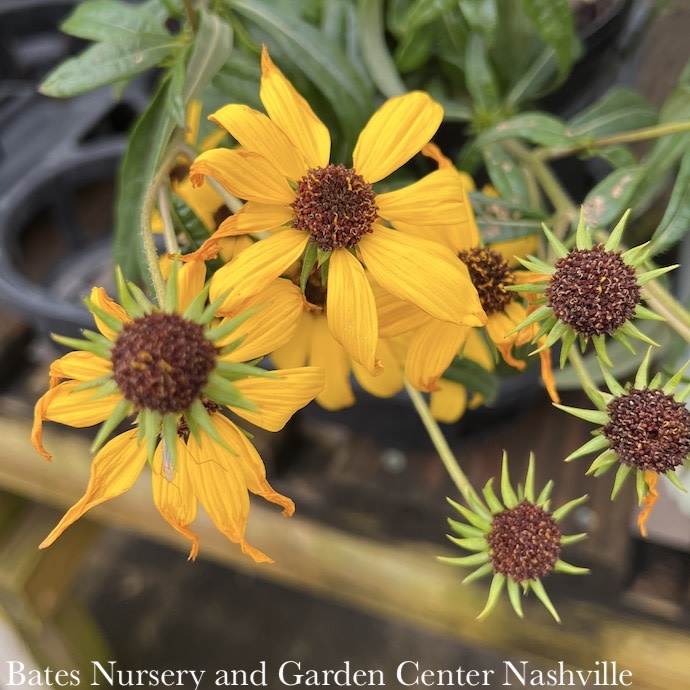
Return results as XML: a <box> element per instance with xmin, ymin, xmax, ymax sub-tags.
<box><xmin>307</xmin><ymin>314</ymin><xmax>355</xmax><ymax>411</ymax></box>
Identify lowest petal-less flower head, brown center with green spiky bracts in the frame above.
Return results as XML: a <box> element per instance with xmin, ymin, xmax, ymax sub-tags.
<box><xmin>439</xmin><ymin>453</ymin><xmax>589</xmax><ymax>623</ymax></box>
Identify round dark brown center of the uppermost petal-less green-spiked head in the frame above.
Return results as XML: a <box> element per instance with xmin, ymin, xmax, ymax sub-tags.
<box><xmin>546</xmin><ymin>244</ymin><xmax>640</xmax><ymax>337</ymax></box>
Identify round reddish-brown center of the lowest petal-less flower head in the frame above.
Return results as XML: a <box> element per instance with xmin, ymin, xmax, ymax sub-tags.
<box><xmin>486</xmin><ymin>501</ymin><xmax>563</xmax><ymax>582</ymax></box>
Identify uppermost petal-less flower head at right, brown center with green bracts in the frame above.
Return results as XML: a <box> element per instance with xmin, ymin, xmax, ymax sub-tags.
<box><xmin>518</xmin><ymin>211</ymin><xmax>677</xmax><ymax>366</ymax></box>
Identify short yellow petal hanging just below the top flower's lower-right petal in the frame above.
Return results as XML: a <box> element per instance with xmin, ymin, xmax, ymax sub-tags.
<box><xmin>405</xmin><ymin>319</ymin><xmax>472</xmax><ymax>391</ymax></box>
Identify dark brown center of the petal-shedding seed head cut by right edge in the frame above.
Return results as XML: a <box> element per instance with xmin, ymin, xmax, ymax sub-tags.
<box><xmin>602</xmin><ymin>388</ymin><xmax>690</xmax><ymax>473</ymax></box>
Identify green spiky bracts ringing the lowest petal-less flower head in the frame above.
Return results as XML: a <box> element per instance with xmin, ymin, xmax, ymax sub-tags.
<box><xmin>438</xmin><ymin>452</ymin><xmax>589</xmax><ymax>622</ymax></box>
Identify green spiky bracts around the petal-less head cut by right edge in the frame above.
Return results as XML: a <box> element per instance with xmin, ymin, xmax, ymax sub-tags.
<box><xmin>555</xmin><ymin>347</ymin><xmax>690</xmax><ymax>504</ymax></box>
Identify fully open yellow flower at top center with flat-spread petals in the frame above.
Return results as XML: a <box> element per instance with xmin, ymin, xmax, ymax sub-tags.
<box><xmin>185</xmin><ymin>49</ymin><xmax>484</xmax><ymax>374</ymax></box>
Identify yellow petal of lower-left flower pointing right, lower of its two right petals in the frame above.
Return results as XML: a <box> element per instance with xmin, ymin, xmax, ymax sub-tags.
<box><xmin>230</xmin><ymin>367</ymin><xmax>324</xmax><ymax>431</ymax></box>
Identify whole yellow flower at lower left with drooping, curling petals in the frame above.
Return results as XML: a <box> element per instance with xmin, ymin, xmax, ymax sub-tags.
<box><xmin>32</xmin><ymin>263</ymin><xmax>323</xmax><ymax>561</ymax></box>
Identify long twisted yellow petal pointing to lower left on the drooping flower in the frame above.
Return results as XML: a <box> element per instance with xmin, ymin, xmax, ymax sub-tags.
<box><xmin>39</xmin><ymin>430</ymin><xmax>146</xmax><ymax>549</ymax></box>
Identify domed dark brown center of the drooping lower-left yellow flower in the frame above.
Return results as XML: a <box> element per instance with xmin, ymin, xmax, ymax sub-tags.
<box><xmin>112</xmin><ymin>313</ymin><xmax>216</xmax><ymax>414</ymax></box>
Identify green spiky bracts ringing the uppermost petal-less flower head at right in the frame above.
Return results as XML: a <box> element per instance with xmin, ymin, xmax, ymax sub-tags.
<box><xmin>507</xmin><ymin>211</ymin><xmax>677</xmax><ymax>368</ymax></box>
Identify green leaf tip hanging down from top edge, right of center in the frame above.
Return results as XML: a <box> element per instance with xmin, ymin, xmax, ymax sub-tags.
<box><xmin>522</xmin><ymin>0</ymin><xmax>580</xmax><ymax>75</ymax></box>
